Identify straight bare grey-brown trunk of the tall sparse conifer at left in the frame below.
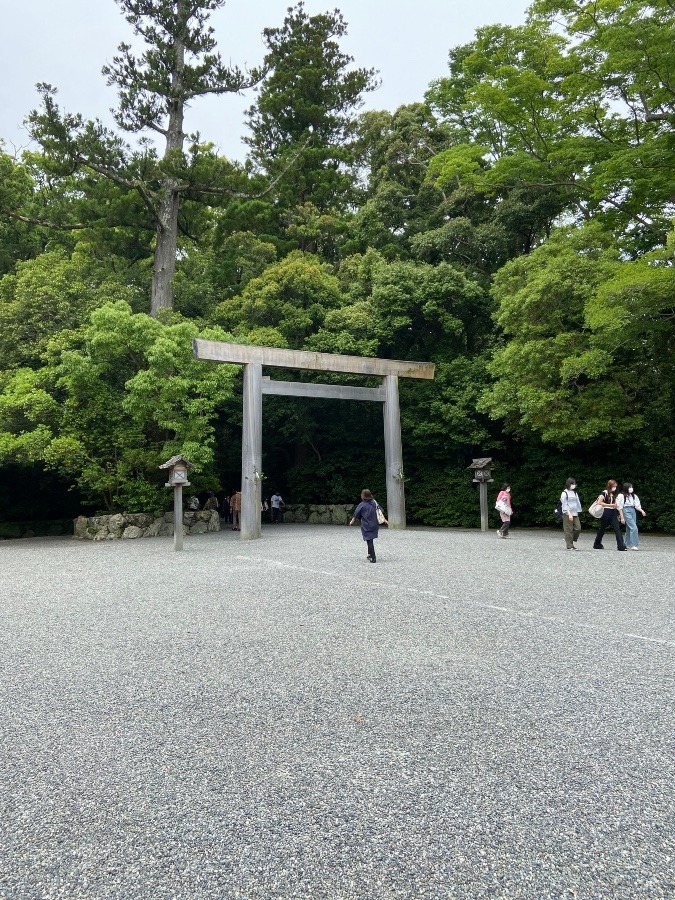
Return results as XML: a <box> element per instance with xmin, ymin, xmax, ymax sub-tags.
<box><xmin>150</xmin><ymin>29</ymin><xmax>185</xmax><ymax>318</ymax></box>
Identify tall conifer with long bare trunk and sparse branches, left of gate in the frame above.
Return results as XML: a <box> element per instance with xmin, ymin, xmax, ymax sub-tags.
<box><xmin>28</xmin><ymin>0</ymin><xmax>261</xmax><ymax>316</ymax></box>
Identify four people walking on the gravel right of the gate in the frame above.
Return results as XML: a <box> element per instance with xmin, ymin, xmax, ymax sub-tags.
<box><xmin>495</xmin><ymin>478</ymin><xmax>647</xmax><ymax>550</ymax></box>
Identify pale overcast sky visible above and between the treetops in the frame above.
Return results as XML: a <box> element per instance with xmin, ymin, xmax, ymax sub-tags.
<box><xmin>0</xmin><ymin>0</ymin><xmax>529</xmax><ymax>159</ymax></box>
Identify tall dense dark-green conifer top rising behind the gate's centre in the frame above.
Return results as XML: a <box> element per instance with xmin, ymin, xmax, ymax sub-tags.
<box><xmin>244</xmin><ymin>3</ymin><xmax>378</xmax><ymax>210</ymax></box>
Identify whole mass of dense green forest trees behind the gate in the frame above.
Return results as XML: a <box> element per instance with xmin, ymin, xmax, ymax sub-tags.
<box><xmin>0</xmin><ymin>0</ymin><xmax>675</xmax><ymax>532</ymax></box>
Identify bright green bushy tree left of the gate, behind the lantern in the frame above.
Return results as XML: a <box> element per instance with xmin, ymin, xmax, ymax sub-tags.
<box><xmin>0</xmin><ymin>301</ymin><xmax>236</xmax><ymax>511</ymax></box>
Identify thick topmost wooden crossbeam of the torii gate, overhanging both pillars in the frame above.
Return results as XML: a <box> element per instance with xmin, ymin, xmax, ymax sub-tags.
<box><xmin>192</xmin><ymin>338</ymin><xmax>436</xmax><ymax>379</ymax></box>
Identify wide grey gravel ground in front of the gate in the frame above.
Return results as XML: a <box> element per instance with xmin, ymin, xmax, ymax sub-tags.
<box><xmin>0</xmin><ymin>525</ymin><xmax>675</xmax><ymax>900</ymax></box>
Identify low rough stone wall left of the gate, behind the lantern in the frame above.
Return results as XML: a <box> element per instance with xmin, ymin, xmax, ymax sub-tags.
<box><xmin>74</xmin><ymin>509</ymin><xmax>220</xmax><ymax>541</ymax></box>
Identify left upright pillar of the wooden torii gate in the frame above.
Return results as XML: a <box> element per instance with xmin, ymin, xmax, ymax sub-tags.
<box><xmin>241</xmin><ymin>363</ymin><xmax>262</xmax><ymax>541</ymax></box>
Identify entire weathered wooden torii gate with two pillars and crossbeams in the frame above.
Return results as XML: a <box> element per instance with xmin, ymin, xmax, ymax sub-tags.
<box><xmin>192</xmin><ymin>338</ymin><xmax>435</xmax><ymax>541</ymax></box>
